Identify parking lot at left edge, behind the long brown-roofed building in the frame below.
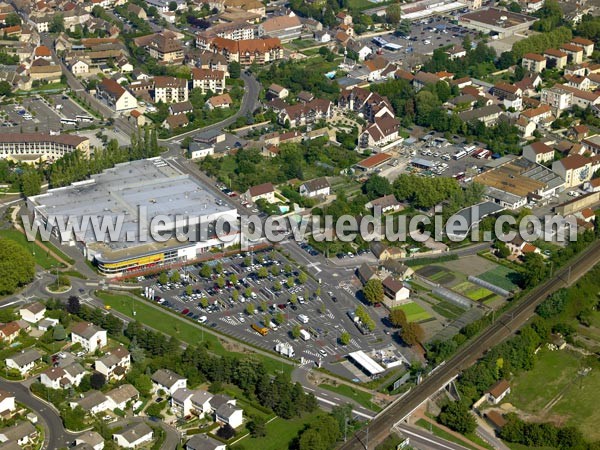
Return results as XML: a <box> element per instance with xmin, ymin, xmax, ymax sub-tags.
<box><xmin>0</xmin><ymin>94</ymin><xmax>97</xmax><ymax>133</ymax></box>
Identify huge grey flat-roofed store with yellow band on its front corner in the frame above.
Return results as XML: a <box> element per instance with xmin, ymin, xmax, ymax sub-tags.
<box><xmin>28</xmin><ymin>158</ymin><xmax>240</xmax><ymax>276</ymax></box>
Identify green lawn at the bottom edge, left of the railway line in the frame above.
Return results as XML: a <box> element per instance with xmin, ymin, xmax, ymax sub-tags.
<box><xmin>232</xmin><ymin>412</ymin><xmax>322</xmax><ymax>450</ymax></box>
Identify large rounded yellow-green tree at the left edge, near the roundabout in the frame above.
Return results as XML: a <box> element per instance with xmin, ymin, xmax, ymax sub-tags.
<box><xmin>0</xmin><ymin>239</ymin><xmax>35</xmax><ymax>295</ymax></box>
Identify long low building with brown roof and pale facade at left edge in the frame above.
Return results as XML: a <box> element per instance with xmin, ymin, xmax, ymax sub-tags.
<box><xmin>0</xmin><ymin>133</ymin><xmax>90</xmax><ymax>163</ymax></box>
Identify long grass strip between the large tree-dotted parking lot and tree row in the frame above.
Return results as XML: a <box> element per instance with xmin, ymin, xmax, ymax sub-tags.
<box><xmin>96</xmin><ymin>292</ymin><xmax>293</xmax><ymax>374</ymax></box>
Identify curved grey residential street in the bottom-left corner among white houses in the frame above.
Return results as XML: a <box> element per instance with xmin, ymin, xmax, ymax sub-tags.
<box><xmin>0</xmin><ymin>379</ymin><xmax>79</xmax><ymax>450</ymax></box>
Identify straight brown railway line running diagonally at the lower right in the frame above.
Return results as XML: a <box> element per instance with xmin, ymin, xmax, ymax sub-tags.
<box><xmin>340</xmin><ymin>242</ymin><xmax>600</xmax><ymax>450</ymax></box>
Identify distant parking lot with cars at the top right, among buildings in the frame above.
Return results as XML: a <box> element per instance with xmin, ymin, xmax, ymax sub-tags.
<box><xmin>363</xmin><ymin>17</ymin><xmax>477</xmax><ymax>68</ymax></box>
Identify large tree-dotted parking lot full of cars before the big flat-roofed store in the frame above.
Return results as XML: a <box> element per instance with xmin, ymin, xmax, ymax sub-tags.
<box><xmin>141</xmin><ymin>251</ymin><xmax>390</xmax><ymax>381</ymax></box>
